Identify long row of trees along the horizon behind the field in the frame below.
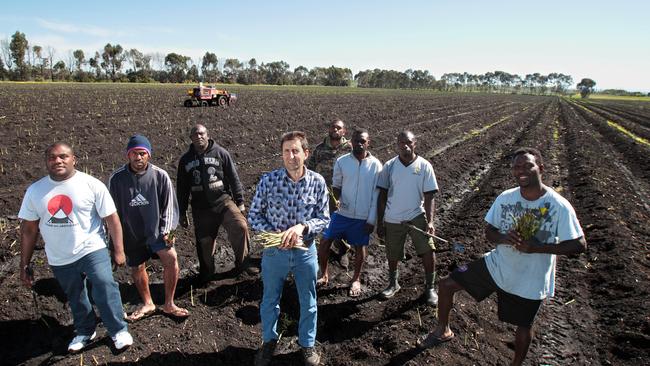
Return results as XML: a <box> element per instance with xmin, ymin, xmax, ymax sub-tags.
<box><xmin>0</xmin><ymin>31</ymin><xmax>624</xmax><ymax>94</ymax></box>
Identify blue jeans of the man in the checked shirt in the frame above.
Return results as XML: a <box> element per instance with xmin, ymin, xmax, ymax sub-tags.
<box><xmin>260</xmin><ymin>244</ymin><xmax>318</xmax><ymax>347</ymax></box>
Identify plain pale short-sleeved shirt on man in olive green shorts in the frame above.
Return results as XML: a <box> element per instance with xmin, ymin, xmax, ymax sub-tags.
<box><xmin>377</xmin><ymin>156</ymin><xmax>438</xmax><ymax>224</ymax></box>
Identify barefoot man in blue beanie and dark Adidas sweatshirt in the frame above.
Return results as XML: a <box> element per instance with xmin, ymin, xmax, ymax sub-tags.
<box><xmin>108</xmin><ymin>135</ymin><xmax>189</xmax><ymax>321</ymax></box>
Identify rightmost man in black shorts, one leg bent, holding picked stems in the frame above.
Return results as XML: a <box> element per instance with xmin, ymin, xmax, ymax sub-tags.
<box><xmin>418</xmin><ymin>148</ymin><xmax>587</xmax><ymax>365</ymax></box>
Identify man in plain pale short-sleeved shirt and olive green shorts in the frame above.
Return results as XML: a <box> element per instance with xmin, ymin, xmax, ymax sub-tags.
<box><xmin>377</xmin><ymin>131</ymin><xmax>438</xmax><ymax>306</ymax></box>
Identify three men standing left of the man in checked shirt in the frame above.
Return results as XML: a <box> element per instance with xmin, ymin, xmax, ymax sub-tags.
<box><xmin>19</xmin><ymin>124</ymin><xmax>259</xmax><ymax>352</ymax></box>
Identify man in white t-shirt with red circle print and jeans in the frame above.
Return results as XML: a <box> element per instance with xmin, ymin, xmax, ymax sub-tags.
<box><xmin>18</xmin><ymin>142</ymin><xmax>133</xmax><ymax>352</ymax></box>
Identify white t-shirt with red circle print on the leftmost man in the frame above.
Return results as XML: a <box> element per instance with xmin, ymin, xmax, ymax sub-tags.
<box><xmin>18</xmin><ymin>171</ymin><xmax>116</xmax><ymax>266</ymax></box>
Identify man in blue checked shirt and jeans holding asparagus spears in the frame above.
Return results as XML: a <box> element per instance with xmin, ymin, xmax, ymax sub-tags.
<box><xmin>248</xmin><ymin>131</ymin><xmax>329</xmax><ymax>366</ymax></box>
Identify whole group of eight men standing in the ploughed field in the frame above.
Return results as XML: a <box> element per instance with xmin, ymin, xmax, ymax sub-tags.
<box><xmin>19</xmin><ymin>120</ymin><xmax>586</xmax><ymax>365</ymax></box>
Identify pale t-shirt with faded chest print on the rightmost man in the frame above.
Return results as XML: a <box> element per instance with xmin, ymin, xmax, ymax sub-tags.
<box><xmin>485</xmin><ymin>187</ymin><xmax>584</xmax><ymax>300</ymax></box>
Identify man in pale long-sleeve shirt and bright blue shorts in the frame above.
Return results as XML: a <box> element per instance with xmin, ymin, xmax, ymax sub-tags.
<box><xmin>318</xmin><ymin>129</ymin><xmax>382</xmax><ymax>297</ymax></box>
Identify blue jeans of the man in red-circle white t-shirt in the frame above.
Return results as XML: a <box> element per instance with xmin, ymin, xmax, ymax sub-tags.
<box><xmin>51</xmin><ymin>248</ymin><xmax>127</xmax><ymax>337</ymax></box>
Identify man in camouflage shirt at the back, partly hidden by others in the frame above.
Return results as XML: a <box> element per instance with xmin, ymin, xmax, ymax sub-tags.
<box><xmin>307</xmin><ymin>119</ymin><xmax>352</xmax><ymax>268</ymax></box>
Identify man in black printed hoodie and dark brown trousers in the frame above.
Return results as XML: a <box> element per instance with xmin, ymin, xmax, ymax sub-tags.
<box><xmin>176</xmin><ymin>124</ymin><xmax>258</xmax><ymax>282</ymax></box>
